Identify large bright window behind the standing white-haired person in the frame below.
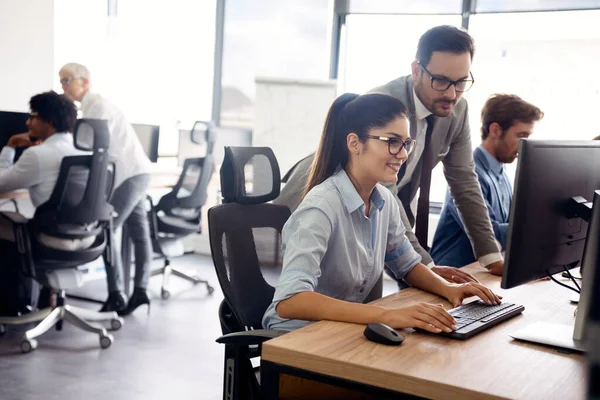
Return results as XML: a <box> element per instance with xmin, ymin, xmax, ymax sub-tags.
<box><xmin>54</xmin><ymin>0</ymin><xmax>216</xmax><ymax>155</ymax></box>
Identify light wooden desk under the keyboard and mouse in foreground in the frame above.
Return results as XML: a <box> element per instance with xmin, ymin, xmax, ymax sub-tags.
<box><xmin>261</xmin><ymin>265</ymin><xmax>585</xmax><ymax>399</ymax></box>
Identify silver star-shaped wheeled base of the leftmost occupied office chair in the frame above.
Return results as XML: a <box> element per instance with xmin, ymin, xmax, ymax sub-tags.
<box><xmin>0</xmin><ymin>305</ymin><xmax>123</xmax><ymax>353</ymax></box>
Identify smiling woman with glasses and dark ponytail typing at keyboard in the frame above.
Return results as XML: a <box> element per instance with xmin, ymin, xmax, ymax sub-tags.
<box><xmin>263</xmin><ymin>93</ymin><xmax>500</xmax><ymax>332</ymax></box>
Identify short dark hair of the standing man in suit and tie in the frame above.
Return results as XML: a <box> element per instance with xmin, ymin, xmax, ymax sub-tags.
<box><xmin>416</xmin><ymin>25</ymin><xmax>475</xmax><ymax>67</ymax></box>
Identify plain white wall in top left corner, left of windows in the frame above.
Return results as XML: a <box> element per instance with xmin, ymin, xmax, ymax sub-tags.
<box><xmin>0</xmin><ymin>0</ymin><xmax>55</xmax><ymax>111</ymax></box>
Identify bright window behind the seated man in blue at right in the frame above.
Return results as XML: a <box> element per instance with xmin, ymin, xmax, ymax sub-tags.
<box><xmin>467</xmin><ymin>11</ymin><xmax>600</xmax><ymax>181</ymax></box>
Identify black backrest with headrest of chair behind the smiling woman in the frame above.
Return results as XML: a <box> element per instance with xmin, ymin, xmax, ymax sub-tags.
<box><xmin>208</xmin><ymin>147</ymin><xmax>290</xmax><ymax>329</ymax></box>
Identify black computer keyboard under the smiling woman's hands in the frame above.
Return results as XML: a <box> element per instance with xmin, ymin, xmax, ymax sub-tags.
<box><xmin>422</xmin><ymin>300</ymin><xmax>525</xmax><ymax>339</ymax></box>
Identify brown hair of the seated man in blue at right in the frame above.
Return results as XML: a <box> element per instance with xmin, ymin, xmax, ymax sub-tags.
<box><xmin>481</xmin><ymin>94</ymin><xmax>544</xmax><ymax>140</ymax></box>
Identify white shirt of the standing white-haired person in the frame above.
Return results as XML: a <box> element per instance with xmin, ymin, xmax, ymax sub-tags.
<box><xmin>81</xmin><ymin>91</ymin><xmax>151</xmax><ymax>189</ymax></box>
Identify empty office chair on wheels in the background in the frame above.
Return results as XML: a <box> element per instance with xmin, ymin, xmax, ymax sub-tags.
<box><xmin>147</xmin><ymin>121</ymin><xmax>216</xmax><ymax>299</ymax></box>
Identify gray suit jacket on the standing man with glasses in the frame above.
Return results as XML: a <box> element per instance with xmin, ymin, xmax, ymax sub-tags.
<box><xmin>274</xmin><ymin>76</ymin><xmax>499</xmax><ymax>264</ymax></box>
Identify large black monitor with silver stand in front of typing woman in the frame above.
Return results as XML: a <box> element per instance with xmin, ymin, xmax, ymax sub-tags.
<box><xmin>501</xmin><ymin>139</ymin><xmax>600</xmax><ymax>351</ymax></box>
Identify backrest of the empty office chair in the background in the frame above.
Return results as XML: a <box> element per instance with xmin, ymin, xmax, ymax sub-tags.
<box><xmin>156</xmin><ymin>154</ymin><xmax>215</xmax><ymax>222</ymax></box>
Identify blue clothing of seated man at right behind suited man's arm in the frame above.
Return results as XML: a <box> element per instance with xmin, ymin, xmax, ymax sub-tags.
<box><xmin>430</xmin><ymin>146</ymin><xmax>512</xmax><ymax>267</ymax></box>
